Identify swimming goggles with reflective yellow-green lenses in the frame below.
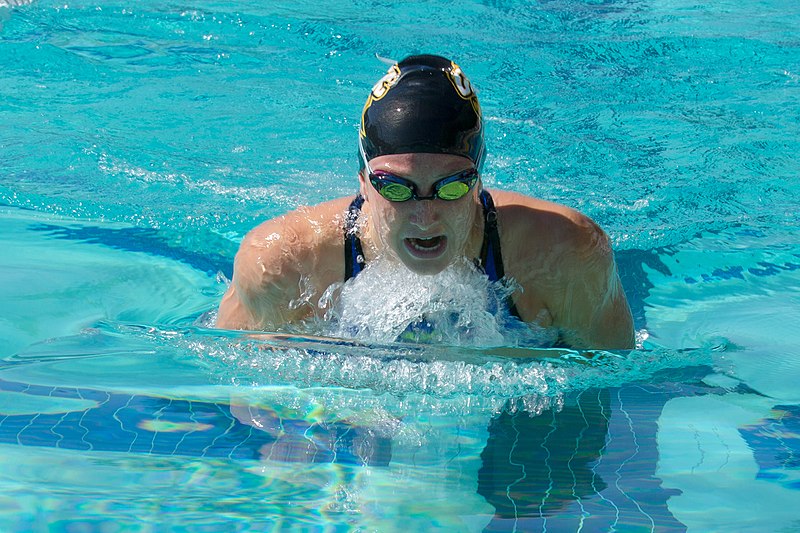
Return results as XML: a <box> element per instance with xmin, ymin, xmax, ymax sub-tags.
<box><xmin>361</xmin><ymin>139</ymin><xmax>478</xmax><ymax>202</ymax></box>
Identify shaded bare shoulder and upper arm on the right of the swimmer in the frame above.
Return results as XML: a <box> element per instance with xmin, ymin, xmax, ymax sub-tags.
<box><xmin>492</xmin><ymin>191</ymin><xmax>634</xmax><ymax>349</ymax></box>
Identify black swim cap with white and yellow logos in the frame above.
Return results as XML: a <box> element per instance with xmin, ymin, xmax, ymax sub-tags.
<box><xmin>359</xmin><ymin>55</ymin><xmax>484</xmax><ymax>169</ymax></box>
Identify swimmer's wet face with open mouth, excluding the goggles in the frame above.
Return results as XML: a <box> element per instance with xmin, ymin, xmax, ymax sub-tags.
<box><xmin>359</xmin><ymin>154</ymin><xmax>482</xmax><ymax>274</ymax></box>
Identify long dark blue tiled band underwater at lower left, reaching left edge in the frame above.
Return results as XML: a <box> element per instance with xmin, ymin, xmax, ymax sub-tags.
<box><xmin>0</xmin><ymin>380</ymin><xmax>391</xmax><ymax>466</ymax></box>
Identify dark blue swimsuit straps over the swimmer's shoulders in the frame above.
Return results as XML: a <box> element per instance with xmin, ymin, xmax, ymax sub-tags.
<box><xmin>344</xmin><ymin>190</ymin><xmax>520</xmax><ymax>318</ymax></box>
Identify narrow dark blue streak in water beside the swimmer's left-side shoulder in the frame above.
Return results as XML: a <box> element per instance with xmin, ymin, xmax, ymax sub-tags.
<box><xmin>30</xmin><ymin>223</ymin><xmax>233</xmax><ymax>279</ymax></box>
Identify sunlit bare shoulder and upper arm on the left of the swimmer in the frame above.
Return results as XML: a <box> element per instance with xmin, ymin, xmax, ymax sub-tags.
<box><xmin>217</xmin><ymin>198</ymin><xmax>350</xmax><ymax>329</ymax></box>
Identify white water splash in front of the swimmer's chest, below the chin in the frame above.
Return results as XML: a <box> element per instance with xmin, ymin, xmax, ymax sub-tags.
<box><xmin>320</xmin><ymin>259</ymin><xmax>552</xmax><ymax>347</ymax></box>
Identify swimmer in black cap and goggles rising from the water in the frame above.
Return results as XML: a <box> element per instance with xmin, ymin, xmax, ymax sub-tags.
<box><xmin>217</xmin><ymin>55</ymin><xmax>634</xmax><ymax>349</ymax></box>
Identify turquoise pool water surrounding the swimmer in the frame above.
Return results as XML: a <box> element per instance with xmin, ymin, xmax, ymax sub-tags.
<box><xmin>0</xmin><ymin>0</ymin><xmax>800</xmax><ymax>531</ymax></box>
